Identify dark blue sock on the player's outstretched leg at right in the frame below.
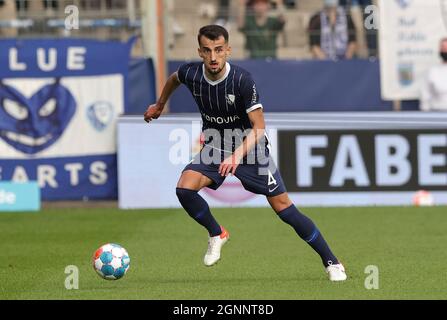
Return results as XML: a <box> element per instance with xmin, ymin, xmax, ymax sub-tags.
<box><xmin>278</xmin><ymin>205</ymin><xmax>338</xmax><ymax>267</ymax></box>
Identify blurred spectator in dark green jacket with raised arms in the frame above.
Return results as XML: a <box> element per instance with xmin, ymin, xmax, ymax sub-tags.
<box><xmin>238</xmin><ymin>0</ymin><xmax>285</xmax><ymax>59</ymax></box>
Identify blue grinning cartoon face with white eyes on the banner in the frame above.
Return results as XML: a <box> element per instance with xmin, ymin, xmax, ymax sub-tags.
<box><xmin>0</xmin><ymin>79</ymin><xmax>76</xmax><ymax>154</ymax></box>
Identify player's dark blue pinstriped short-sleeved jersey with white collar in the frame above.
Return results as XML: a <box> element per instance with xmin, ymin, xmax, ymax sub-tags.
<box><xmin>177</xmin><ymin>62</ymin><xmax>262</xmax><ymax>152</ymax></box>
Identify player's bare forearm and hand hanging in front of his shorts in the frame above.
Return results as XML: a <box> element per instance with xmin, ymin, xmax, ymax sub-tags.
<box><xmin>219</xmin><ymin>108</ymin><xmax>265</xmax><ymax>176</ymax></box>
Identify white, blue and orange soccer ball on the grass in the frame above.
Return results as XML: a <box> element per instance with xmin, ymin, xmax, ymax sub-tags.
<box><xmin>93</xmin><ymin>243</ymin><xmax>130</xmax><ymax>280</ymax></box>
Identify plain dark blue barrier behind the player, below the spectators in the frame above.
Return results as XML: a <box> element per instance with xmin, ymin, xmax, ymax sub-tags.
<box><xmin>169</xmin><ymin>59</ymin><xmax>418</xmax><ymax>113</ymax></box>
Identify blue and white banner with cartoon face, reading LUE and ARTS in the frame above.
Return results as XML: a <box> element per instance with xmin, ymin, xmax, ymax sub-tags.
<box><xmin>0</xmin><ymin>39</ymin><xmax>133</xmax><ymax>200</ymax></box>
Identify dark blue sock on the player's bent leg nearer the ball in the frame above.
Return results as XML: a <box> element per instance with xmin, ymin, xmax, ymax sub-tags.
<box><xmin>176</xmin><ymin>188</ymin><xmax>222</xmax><ymax>237</ymax></box>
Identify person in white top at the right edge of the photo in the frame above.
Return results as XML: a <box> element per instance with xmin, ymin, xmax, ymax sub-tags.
<box><xmin>420</xmin><ymin>38</ymin><xmax>447</xmax><ymax>111</ymax></box>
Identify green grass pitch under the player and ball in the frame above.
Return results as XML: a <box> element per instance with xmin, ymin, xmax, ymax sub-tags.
<box><xmin>0</xmin><ymin>207</ymin><xmax>447</xmax><ymax>300</ymax></box>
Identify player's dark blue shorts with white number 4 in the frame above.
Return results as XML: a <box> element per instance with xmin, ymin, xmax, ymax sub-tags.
<box><xmin>183</xmin><ymin>146</ymin><xmax>286</xmax><ymax>197</ymax></box>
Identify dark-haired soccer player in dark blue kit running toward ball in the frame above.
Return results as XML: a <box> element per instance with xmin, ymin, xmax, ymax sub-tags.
<box><xmin>144</xmin><ymin>25</ymin><xmax>346</xmax><ymax>281</ymax></box>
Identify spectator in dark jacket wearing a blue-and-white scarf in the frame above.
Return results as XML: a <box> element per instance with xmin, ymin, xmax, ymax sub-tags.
<box><xmin>309</xmin><ymin>0</ymin><xmax>356</xmax><ymax>60</ymax></box>
